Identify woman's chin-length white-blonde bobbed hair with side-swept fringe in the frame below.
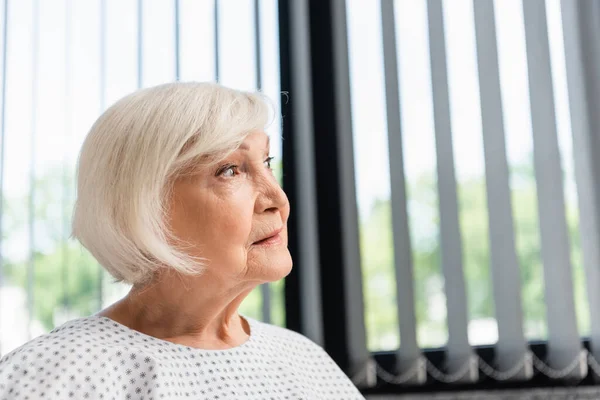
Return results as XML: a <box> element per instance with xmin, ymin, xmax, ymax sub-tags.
<box><xmin>72</xmin><ymin>82</ymin><xmax>272</xmax><ymax>284</ymax></box>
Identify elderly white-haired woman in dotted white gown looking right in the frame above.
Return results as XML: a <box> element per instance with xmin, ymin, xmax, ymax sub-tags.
<box><xmin>0</xmin><ymin>83</ymin><xmax>363</xmax><ymax>400</ymax></box>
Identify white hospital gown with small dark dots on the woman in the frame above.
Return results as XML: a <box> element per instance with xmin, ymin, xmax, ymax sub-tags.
<box><xmin>0</xmin><ymin>316</ymin><xmax>364</xmax><ymax>400</ymax></box>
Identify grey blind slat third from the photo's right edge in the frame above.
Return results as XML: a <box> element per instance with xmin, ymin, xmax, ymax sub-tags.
<box><xmin>473</xmin><ymin>0</ymin><xmax>533</xmax><ymax>378</ymax></box>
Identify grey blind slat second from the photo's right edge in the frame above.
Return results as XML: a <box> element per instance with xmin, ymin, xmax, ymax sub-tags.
<box><xmin>523</xmin><ymin>0</ymin><xmax>587</xmax><ymax>376</ymax></box>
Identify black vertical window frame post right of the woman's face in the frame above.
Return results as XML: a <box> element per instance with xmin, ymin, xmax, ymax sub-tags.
<box><xmin>308</xmin><ymin>0</ymin><xmax>352</xmax><ymax>370</ymax></box>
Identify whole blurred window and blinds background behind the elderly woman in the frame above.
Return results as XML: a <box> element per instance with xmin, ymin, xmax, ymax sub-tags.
<box><xmin>0</xmin><ymin>0</ymin><xmax>600</xmax><ymax>393</ymax></box>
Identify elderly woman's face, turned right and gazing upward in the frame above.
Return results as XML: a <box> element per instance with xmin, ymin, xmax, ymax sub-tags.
<box><xmin>170</xmin><ymin>132</ymin><xmax>292</xmax><ymax>284</ymax></box>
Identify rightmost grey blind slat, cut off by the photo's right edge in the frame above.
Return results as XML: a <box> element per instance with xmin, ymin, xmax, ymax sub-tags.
<box><xmin>562</xmin><ymin>1</ymin><xmax>600</xmax><ymax>366</ymax></box>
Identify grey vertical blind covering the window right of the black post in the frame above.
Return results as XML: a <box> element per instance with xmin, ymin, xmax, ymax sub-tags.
<box><xmin>332</xmin><ymin>0</ymin><xmax>600</xmax><ymax>386</ymax></box>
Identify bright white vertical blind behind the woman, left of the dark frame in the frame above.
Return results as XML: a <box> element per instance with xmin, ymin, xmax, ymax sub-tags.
<box><xmin>0</xmin><ymin>0</ymin><xmax>284</xmax><ymax>355</ymax></box>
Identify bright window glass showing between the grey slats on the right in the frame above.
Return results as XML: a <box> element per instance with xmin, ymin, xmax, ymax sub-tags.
<box><xmin>346</xmin><ymin>0</ymin><xmax>589</xmax><ymax>351</ymax></box>
